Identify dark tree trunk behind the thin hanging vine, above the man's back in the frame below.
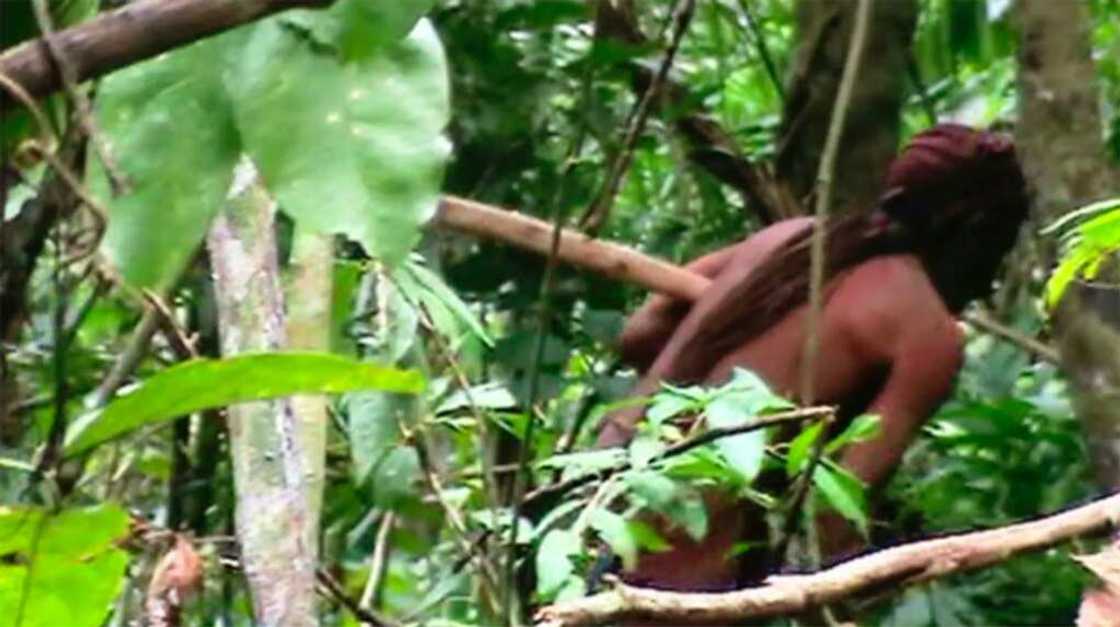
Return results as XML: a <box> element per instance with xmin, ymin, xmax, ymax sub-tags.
<box><xmin>775</xmin><ymin>0</ymin><xmax>917</xmax><ymax>212</ymax></box>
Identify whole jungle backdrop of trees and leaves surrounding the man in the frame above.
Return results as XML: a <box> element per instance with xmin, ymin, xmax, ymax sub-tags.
<box><xmin>0</xmin><ymin>0</ymin><xmax>1120</xmax><ymax>627</ymax></box>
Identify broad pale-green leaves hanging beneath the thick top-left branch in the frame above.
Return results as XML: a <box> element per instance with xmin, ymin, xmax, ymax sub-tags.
<box><xmin>93</xmin><ymin>0</ymin><xmax>449</xmax><ymax>289</ymax></box>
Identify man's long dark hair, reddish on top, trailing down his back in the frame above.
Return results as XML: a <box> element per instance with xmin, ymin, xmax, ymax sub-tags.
<box><xmin>661</xmin><ymin>124</ymin><xmax>1028</xmax><ymax>383</ymax></box>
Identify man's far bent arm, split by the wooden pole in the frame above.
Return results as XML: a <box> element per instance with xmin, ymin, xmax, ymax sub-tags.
<box><xmin>618</xmin><ymin>243</ymin><xmax>741</xmax><ymax>373</ymax></box>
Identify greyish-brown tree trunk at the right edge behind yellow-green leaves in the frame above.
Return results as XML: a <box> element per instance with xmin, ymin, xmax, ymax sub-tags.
<box><xmin>1016</xmin><ymin>0</ymin><xmax>1120</xmax><ymax>490</ymax></box>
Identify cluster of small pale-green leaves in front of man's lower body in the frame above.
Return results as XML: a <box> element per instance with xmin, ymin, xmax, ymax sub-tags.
<box><xmin>532</xmin><ymin>369</ymin><xmax>878</xmax><ymax>600</ymax></box>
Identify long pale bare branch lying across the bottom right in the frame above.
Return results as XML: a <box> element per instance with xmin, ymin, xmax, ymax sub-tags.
<box><xmin>536</xmin><ymin>494</ymin><xmax>1120</xmax><ymax>627</ymax></box>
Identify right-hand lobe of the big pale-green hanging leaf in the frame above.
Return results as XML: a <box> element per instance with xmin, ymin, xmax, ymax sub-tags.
<box><xmin>226</xmin><ymin>16</ymin><xmax>449</xmax><ymax>263</ymax></box>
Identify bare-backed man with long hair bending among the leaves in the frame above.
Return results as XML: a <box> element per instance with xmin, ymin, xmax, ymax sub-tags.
<box><xmin>599</xmin><ymin>124</ymin><xmax>1027</xmax><ymax>590</ymax></box>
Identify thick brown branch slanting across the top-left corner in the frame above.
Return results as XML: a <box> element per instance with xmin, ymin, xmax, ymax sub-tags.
<box><xmin>0</xmin><ymin>0</ymin><xmax>334</xmax><ymax>101</ymax></box>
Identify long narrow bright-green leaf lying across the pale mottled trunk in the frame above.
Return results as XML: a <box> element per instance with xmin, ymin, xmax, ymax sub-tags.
<box><xmin>66</xmin><ymin>353</ymin><xmax>423</xmax><ymax>455</ymax></box>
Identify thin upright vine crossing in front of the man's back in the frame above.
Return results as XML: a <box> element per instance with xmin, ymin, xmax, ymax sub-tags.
<box><xmin>792</xmin><ymin>0</ymin><xmax>871</xmax><ymax>573</ymax></box>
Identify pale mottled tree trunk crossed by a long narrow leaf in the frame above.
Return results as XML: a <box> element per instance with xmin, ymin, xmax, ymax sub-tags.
<box><xmin>206</xmin><ymin>161</ymin><xmax>321</xmax><ymax>626</ymax></box>
